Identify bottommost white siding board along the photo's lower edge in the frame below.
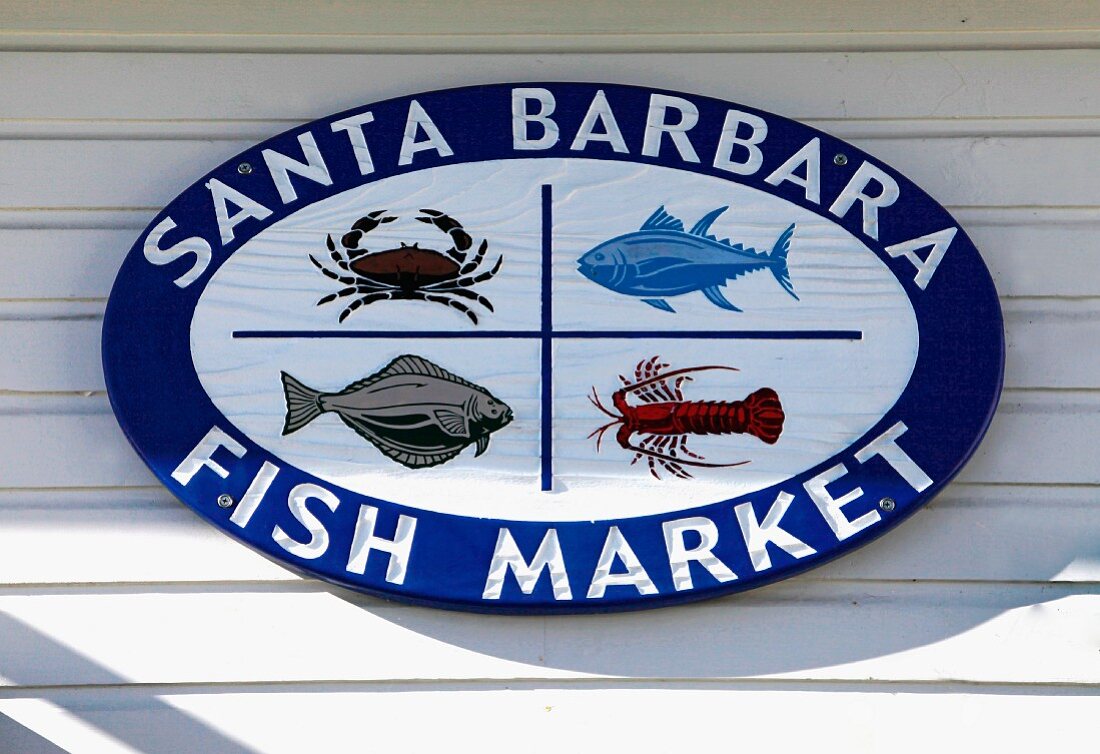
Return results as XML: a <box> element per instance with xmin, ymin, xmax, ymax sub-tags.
<box><xmin>0</xmin><ymin>682</ymin><xmax>1096</xmax><ymax>754</ymax></box>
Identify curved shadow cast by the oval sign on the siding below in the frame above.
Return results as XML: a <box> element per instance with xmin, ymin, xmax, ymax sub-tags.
<box><xmin>331</xmin><ymin>497</ymin><xmax>1096</xmax><ymax>680</ymax></box>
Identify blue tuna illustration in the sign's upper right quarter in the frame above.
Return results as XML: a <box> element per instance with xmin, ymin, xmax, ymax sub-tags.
<box><xmin>578</xmin><ymin>206</ymin><xmax>799</xmax><ymax>312</ymax></box>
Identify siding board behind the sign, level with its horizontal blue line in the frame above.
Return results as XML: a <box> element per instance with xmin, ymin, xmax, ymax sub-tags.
<box><xmin>0</xmin><ymin>297</ymin><xmax>1100</xmax><ymax>392</ymax></box>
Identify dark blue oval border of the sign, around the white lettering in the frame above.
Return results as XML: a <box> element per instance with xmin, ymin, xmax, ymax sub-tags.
<box><xmin>102</xmin><ymin>83</ymin><xmax>1004</xmax><ymax>613</ymax></box>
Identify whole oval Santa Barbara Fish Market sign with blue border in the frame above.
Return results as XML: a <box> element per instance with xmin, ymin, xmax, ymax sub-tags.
<box><xmin>103</xmin><ymin>84</ymin><xmax>1004</xmax><ymax>612</ymax></box>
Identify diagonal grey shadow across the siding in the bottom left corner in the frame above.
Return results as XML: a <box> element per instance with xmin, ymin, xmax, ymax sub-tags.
<box><xmin>0</xmin><ymin>612</ymin><xmax>256</xmax><ymax>754</ymax></box>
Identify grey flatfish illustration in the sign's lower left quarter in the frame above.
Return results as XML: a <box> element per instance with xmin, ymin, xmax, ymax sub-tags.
<box><xmin>283</xmin><ymin>354</ymin><xmax>513</xmax><ymax>469</ymax></box>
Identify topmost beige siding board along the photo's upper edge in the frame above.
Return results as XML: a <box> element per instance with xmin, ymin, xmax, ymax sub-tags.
<box><xmin>6</xmin><ymin>0</ymin><xmax>1100</xmax><ymax>37</ymax></box>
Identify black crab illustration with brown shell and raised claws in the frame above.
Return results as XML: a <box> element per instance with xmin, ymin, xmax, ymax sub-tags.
<box><xmin>309</xmin><ymin>209</ymin><xmax>504</xmax><ymax>325</ymax></box>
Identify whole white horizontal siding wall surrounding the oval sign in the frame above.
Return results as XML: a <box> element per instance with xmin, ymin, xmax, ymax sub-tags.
<box><xmin>0</xmin><ymin>0</ymin><xmax>1100</xmax><ymax>754</ymax></box>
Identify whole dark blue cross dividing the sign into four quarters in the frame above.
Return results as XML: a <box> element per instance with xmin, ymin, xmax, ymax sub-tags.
<box><xmin>233</xmin><ymin>184</ymin><xmax>864</xmax><ymax>492</ymax></box>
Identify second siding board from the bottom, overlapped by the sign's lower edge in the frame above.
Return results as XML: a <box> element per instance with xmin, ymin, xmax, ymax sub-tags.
<box><xmin>0</xmin><ymin>583</ymin><xmax>1100</xmax><ymax>686</ymax></box>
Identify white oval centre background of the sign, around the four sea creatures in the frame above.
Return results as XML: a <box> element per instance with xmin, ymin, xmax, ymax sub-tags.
<box><xmin>191</xmin><ymin>159</ymin><xmax>917</xmax><ymax>521</ymax></box>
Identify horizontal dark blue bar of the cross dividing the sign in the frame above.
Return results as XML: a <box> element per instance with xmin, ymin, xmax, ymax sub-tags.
<box><xmin>233</xmin><ymin>330</ymin><xmax>864</xmax><ymax>340</ymax></box>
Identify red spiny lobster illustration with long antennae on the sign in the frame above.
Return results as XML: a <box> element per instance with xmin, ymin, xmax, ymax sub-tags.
<box><xmin>589</xmin><ymin>356</ymin><xmax>783</xmax><ymax>479</ymax></box>
